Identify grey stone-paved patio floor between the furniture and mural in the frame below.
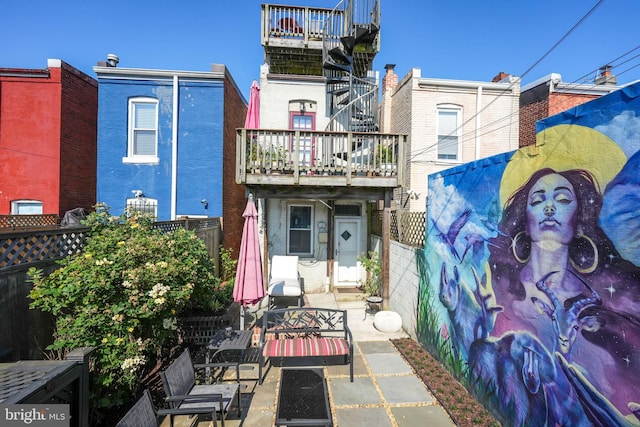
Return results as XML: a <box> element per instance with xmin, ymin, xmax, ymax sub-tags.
<box><xmin>163</xmin><ymin>293</ymin><xmax>455</xmax><ymax>427</ymax></box>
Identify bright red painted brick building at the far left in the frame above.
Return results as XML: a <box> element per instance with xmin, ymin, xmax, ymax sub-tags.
<box><xmin>0</xmin><ymin>59</ymin><xmax>98</xmax><ymax>217</ymax></box>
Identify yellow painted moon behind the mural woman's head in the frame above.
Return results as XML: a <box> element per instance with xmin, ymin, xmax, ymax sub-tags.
<box><xmin>500</xmin><ymin>125</ymin><xmax>627</xmax><ymax>206</ymax></box>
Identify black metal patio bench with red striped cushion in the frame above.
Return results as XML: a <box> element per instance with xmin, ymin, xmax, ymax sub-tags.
<box><xmin>259</xmin><ymin>308</ymin><xmax>353</xmax><ymax>384</ymax></box>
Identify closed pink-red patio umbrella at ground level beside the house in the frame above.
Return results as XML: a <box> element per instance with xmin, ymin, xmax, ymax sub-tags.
<box><xmin>233</xmin><ymin>195</ymin><xmax>265</xmax><ymax>329</ymax></box>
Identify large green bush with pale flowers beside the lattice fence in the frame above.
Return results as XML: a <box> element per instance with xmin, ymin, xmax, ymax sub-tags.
<box><xmin>29</xmin><ymin>209</ymin><xmax>231</xmax><ymax>418</ymax></box>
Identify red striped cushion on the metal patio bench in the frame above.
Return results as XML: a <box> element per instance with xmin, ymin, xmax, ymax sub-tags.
<box><xmin>262</xmin><ymin>338</ymin><xmax>349</xmax><ymax>357</ymax></box>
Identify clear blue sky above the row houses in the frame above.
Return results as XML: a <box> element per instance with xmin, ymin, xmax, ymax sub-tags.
<box><xmin>0</xmin><ymin>0</ymin><xmax>640</xmax><ymax>99</ymax></box>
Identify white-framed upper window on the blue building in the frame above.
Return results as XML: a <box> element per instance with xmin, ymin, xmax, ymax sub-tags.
<box><xmin>122</xmin><ymin>97</ymin><xmax>159</xmax><ymax>163</ymax></box>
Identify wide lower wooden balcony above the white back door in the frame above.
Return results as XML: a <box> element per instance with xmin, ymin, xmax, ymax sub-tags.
<box><xmin>236</xmin><ymin>129</ymin><xmax>406</xmax><ymax>197</ymax></box>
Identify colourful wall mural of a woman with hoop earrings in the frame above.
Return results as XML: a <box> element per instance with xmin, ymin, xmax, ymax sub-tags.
<box><xmin>418</xmin><ymin>83</ymin><xmax>640</xmax><ymax>426</ymax></box>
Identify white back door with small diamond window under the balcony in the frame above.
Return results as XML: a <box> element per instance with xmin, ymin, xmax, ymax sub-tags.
<box><xmin>333</xmin><ymin>218</ymin><xmax>360</xmax><ymax>286</ymax></box>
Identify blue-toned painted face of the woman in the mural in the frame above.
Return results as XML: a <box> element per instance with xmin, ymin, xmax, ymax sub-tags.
<box><xmin>527</xmin><ymin>173</ymin><xmax>578</xmax><ymax>245</ymax></box>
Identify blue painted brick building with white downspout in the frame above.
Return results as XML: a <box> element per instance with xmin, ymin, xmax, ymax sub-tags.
<box><xmin>94</xmin><ymin>62</ymin><xmax>247</xmax><ymax>231</ymax></box>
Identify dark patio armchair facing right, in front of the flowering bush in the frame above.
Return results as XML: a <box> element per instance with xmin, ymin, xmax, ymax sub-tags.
<box><xmin>160</xmin><ymin>349</ymin><xmax>242</xmax><ymax>427</ymax></box>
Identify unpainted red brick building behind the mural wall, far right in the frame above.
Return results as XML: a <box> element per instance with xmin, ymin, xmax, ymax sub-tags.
<box><xmin>519</xmin><ymin>71</ymin><xmax>620</xmax><ymax>147</ymax></box>
